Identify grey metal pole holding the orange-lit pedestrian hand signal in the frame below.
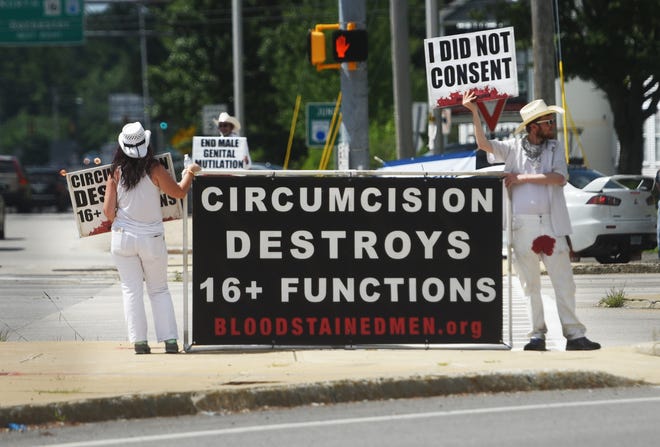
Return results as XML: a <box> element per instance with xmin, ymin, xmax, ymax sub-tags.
<box><xmin>338</xmin><ymin>0</ymin><xmax>368</xmax><ymax>169</ymax></box>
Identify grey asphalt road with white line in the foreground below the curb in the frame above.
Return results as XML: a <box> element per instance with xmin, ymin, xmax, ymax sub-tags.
<box><xmin>0</xmin><ymin>387</ymin><xmax>660</xmax><ymax>447</ymax></box>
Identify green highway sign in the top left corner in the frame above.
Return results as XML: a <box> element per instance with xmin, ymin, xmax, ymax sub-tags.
<box><xmin>0</xmin><ymin>0</ymin><xmax>84</xmax><ymax>45</ymax></box>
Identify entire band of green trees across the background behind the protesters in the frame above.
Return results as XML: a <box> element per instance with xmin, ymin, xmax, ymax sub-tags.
<box><xmin>11</xmin><ymin>0</ymin><xmax>660</xmax><ymax>172</ymax></box>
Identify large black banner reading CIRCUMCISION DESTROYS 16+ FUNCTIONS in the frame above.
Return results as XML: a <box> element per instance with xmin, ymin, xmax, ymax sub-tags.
<box><xmin>192</xmin><ymin>175</ymin><xmax>502</xmax><ymax>345</ymax></box>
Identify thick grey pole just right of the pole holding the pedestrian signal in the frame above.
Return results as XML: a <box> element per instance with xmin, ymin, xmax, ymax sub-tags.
<box><xmin>390</xmin><ymin>0</ymin><xmax>415</xmax><ymax>159</ymax></box>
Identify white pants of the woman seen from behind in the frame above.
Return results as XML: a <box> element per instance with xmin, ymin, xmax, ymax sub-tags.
<box><xmin>110</xmin><ymin>229</ymin><xmax>178</xmax><ymax>343</ymax></box>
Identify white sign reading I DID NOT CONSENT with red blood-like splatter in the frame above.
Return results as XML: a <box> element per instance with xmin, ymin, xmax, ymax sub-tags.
<box><xmin>424</xmin><ymin>27</ymin><xmax>518</xmax><ymax>108</ymax></box>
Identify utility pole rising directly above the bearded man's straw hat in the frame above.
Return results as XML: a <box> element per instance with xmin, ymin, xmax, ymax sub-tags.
<box><xmin>530</xmin><ymin>0</ymin><xmax>555</xmax><ymax>104</ymax></box>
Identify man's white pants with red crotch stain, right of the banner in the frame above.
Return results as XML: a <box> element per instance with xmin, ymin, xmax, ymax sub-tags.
<box><xmin>511</xmin><ymin>214</ymin><xmax>586</xmax><ymax>340</ymax></box>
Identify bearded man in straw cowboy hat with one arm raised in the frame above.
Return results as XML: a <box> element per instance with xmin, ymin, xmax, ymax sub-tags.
<box><xmin>463</xmin><ymin>92</ymin><xmax>600</xmax><ymax>351</ymax></box>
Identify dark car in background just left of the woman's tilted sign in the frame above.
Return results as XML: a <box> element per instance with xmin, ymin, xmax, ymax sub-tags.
<box><xmin>25</xmin><ymin>166</ymin><xmax>71</xmax><ymax>211</ymax></box>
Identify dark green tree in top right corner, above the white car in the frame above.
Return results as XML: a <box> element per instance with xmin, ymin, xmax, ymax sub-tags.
<box><xmin>559</xmin><ymin>0</ymin><xmax>660</xmax><ymax>174</ymax></box>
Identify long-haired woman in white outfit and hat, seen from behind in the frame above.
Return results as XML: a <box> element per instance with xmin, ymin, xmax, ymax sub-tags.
<box><xmin>103</xmin><ymin>122</ymin><xmax>200</xmax><ymax>354</ymax></box>
